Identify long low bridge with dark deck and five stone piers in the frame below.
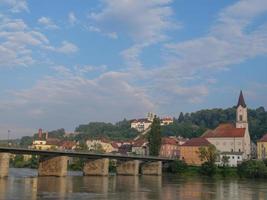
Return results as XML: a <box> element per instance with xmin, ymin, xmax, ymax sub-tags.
<box><xmin>0</xmin><ymin>147</ymin><xmax>174</xmax><ymax>177</ymax></box>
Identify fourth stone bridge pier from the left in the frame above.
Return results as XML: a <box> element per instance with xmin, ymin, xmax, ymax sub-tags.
<box><xmin>117</xmin><ymin>160</ymin><xmax>140</xmax><ymax>176</ymax></box>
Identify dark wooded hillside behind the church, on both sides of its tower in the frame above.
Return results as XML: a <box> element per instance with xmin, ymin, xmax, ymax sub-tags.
<box><xmin>162</xmin><ymin>107</ymin><xmax>267</xmax><ymax>141</ymax></box>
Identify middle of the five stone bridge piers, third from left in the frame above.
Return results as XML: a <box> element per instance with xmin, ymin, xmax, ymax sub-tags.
<box><xmin>83</xmin><ymin>158</ymin><xmax>109</xmax><ymax>176</ymax></box>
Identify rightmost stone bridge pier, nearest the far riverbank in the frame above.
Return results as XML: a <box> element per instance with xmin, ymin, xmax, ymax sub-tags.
<box><xmin>141</xmin><ymin>161</ymin><xmax>162</xmax><ymax>176</ymax></box>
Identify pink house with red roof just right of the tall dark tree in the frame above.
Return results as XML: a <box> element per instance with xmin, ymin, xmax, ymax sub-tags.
<box><xmin>159</xmin><ymin>137</ymin><xmax>180</xmax><ymax>158</ymax></box>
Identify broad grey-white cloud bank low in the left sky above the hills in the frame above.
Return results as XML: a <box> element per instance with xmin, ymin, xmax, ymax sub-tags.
<box><xmin>0</xmin><ymin>66</ymin><xmax>154</xmax><ymax>133</ymax></box>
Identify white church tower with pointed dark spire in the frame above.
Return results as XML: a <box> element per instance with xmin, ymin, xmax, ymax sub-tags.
<box><xmin>236</xmin><ymin>90</ymin><xmax>248</xmax><ymax>129</ymax></box>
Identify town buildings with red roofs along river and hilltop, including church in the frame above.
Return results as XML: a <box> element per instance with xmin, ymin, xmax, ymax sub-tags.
<box><xmin>2</xmin><ymin>91</ymin><xmax>267</xmax><ymax>170</ymax></box>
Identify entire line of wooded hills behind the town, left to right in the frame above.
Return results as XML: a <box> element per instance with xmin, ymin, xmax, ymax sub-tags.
<box><xmin>17</xmin><ymin>107</ymin><xmax>267</xmax><ymax>146</ymax></box>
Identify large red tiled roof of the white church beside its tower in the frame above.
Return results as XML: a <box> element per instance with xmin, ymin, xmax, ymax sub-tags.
<box><xmin>202</xmin><ymin>124</ymin><xmax>246</xmax><ymax>138</ymax></box>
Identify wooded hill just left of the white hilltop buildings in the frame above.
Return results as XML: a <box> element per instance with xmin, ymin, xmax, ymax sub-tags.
<box><xmin>75</xmin><ymin>119</ymin><xmax>138</xmax><ymax>141</ymax></box>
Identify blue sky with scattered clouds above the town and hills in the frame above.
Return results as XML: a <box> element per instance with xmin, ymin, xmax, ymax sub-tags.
<box><xmin>0</xmin><ymin>0</ymin><xmax>267</xmax><ymax>139</ymax></box>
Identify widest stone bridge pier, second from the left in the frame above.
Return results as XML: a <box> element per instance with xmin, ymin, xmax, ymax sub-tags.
<box><xmin>38</xmin><ymin>156</ymin><xmax>68</xmax><ymax>177</ymax></box>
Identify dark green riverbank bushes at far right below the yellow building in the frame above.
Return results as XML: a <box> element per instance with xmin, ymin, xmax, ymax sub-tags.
<box><xmin>237</xmin><ymin>160</ymin><xmax>267</xmax><ymax>178</ymax></box>
